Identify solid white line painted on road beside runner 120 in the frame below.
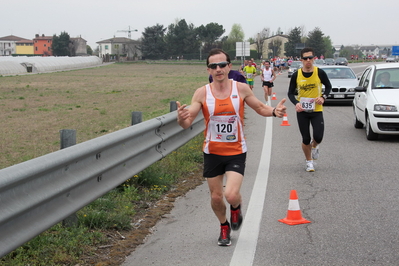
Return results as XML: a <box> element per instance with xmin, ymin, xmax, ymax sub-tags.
<box><xmin>230</xmin><ymin>117</ymin><xmax>273</xmax><ymax>266</ymax></box>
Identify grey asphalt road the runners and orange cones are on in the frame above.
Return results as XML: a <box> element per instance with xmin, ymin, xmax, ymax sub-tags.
<box><xmin>123</xmin><ymin>64</ymin><xmax>399</xmax><ymax>266</ymax></box>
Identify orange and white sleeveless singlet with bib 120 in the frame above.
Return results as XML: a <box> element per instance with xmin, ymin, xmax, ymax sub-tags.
<box><xmin>202</xmin><ymin>80</ymin><xmax>247</xmax><ymax>156</ymax></box>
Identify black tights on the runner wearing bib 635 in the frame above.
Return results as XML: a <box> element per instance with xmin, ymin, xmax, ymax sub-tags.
<box><xmin>297</xmin><ymin>112</ymin><xmax>324</xmax><ymax>145</ymax></box>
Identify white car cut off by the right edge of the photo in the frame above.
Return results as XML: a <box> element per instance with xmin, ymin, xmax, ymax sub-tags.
<box><xmin>353</xmin><ymin>63</ymin><xmax>399</xmax><ymax>140</ymax></box>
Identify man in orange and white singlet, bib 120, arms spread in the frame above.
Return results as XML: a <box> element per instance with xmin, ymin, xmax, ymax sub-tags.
<box><xmin>177</xmin><ymin>49</ymin><xmax>286</xmax><ymax>246</ymax></box>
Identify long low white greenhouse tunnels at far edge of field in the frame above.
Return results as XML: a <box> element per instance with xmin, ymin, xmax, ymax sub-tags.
<box><xmin>0</xmin><ymin>56</ymin><xmax>102</xmax><ymax>75</ymax></box>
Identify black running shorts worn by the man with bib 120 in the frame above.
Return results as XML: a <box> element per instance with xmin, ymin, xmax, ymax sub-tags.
<box><xmin>203</xmin><ymin>153</ymin><xmax>247</xmax><ymax>178</ymax></box>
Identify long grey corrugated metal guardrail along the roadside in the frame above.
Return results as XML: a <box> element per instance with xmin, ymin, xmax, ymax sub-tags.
<box><xmin>0</xmin><ymin>111</ymin><xmax>205</xmax><ymax>257</ymax></box>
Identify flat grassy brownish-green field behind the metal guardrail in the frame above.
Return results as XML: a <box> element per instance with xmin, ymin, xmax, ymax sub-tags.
<box><xmin>0</xmin><ymin>63</ymin><xmax>211</xmax><ymax>169</ymax></box>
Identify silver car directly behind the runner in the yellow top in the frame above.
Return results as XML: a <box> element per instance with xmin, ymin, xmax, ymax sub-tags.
<box><xmin>318</xmin><ymin>65</ymin><xmax>358</xmax><ymax>102</ymax></box>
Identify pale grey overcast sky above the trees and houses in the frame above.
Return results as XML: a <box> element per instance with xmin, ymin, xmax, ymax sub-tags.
<box><xmin>0</xmin><ymin>0</ymin><xmax>399</xmax><ymax>49</ymax></box>
